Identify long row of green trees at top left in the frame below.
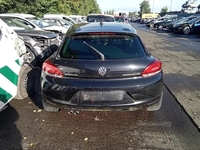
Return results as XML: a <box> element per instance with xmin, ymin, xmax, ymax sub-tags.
<box><xmin>0</xmin><ymin>0</ymin><xmax>101</xmax><ymax>16</ymax></box>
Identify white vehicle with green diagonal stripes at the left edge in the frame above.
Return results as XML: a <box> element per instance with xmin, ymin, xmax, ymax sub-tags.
<box><xmin>0</xmin><ymin>19</ymin><xmax>26</xmax><ymax>111</ymax></box>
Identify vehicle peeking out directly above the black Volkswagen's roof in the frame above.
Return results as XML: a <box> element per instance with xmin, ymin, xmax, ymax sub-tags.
<box><xmin>86</xmin><ymin>14</ymin><xmax>115</xmax><ymax>22</ymax></box>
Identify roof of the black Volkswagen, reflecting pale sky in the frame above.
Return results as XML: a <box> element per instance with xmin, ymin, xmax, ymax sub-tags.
<box><xmin>67</xmin><ymin>22</ymin><xmax>137</xmax><ymax>35</ymax></box>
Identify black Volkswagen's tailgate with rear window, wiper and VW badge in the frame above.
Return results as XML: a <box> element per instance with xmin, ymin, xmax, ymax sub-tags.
<box><xmin>53</xmin><ymin>33</ymin><xmax>154</xmax><ymax>78</ymax></box>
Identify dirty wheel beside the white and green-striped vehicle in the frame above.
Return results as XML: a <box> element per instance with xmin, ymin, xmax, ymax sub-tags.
<box><xmin>15</xmin><ymin>64</ymin><xmax>35</xmax><ymax>99</ymax></box>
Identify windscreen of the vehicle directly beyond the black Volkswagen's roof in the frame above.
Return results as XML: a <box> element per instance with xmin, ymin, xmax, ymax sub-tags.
<box><xmin>87</xmin><ymin>15</ymin><xmax>115</xmax><ymax>22</ymax></box>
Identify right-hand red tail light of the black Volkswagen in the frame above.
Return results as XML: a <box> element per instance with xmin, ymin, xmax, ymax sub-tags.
<box><xmin>142</xmin><ymin>59</ymin><xmax>162</xmax><ymax>77</ymax></box>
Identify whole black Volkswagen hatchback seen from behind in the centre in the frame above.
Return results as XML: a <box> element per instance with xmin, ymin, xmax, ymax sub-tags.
<box><xmin>41</xmin><ymin>22</ymin><xmax>163</xmax><ymax>112</ymax></box>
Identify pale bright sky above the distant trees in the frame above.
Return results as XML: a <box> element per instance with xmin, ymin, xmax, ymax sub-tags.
<box><xmin>96</xmin><ymin>0</ymin><xmax>200</xmax><ymax>13</ymax></box>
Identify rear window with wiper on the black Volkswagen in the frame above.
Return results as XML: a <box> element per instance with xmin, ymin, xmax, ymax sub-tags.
<box><xmin>60</xmin><ymin>35</ymin><xmax>146</xmax><ymax>60</ymax></box>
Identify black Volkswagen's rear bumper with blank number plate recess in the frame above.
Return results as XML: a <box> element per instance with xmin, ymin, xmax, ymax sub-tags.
<box><xmin>42</xmin><ymin>73</ymin><xmax>163</xmax><ymax>110</ymax></box>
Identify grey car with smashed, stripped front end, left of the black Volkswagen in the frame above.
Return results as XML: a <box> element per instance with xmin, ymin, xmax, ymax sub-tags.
<box><xmin>0</xmin><ymin>16</ymin><xmax>61</xmax><ymax>64</ymax></box>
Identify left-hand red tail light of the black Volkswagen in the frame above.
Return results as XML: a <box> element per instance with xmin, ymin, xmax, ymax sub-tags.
<box><xmin>42</xmin><ymin>59</ymin><xmax>64</xmax><ymax>78</ymax></box>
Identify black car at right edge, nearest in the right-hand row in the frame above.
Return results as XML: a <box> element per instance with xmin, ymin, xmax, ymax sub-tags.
<box><xmin>173</xmin><ymin>17</ymin><xmax>200</xmax><ymax>34</ymax></box>
